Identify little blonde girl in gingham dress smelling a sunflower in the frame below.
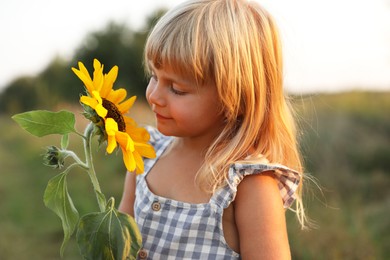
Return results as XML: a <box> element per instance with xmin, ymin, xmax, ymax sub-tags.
<box><xmin>119</xmin><ymin>0</ymin><xmax>305</xmax><ymax>260</ymax></box>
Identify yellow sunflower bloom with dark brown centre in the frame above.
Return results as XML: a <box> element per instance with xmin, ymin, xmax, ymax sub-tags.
<box><xmin>72</xmin><ymin>59</ymin><xmax>156</xmax><ymax>174</ymax></box>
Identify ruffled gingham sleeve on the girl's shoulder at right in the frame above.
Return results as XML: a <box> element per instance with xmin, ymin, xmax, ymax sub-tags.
<box><xmin>216</xmin><ymin>163</ymin><xmax>301</xmax><ymax>208</ymax></box>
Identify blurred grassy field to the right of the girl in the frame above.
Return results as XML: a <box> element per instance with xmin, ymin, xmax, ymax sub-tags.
<box><xmin>289</xmin><ymin>92</ymin><xmax>390</xmax><ymax>259</ymax></box>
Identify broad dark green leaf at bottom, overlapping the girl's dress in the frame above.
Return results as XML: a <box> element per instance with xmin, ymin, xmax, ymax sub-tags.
<box><xmin>76</xmin><ymin>198</ymin><xmax>142</xmax><ymax>260</ymax></box>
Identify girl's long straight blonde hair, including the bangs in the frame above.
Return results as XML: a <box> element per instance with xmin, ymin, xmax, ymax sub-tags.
<box><xmin>145</xmin><ymin>0</ymin><xmax>306</xmax><ymax>226</ymax></box>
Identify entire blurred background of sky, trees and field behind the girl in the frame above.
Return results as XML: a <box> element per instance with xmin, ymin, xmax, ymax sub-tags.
<box><xmin>0</xmin><ymin>0</ymin><xmax>390</xmax><ymax>260</ymax></box>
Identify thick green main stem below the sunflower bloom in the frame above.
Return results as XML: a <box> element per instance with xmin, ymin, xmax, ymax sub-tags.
<box><xmin>84</xmin><ymin>123</ymin><xmax>106</xmax><ymax>212</ymax></box>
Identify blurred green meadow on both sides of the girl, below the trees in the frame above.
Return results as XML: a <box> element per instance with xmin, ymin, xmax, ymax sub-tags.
<box><xmin>0</xmin><ymin>92</ymin><xmax>390</xmax><ymax>260</ymax></box>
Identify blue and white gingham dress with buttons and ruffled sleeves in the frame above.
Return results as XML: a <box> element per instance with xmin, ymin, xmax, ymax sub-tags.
<box><xmin>134</xmin><ymin>128</ymin><xmax>300</xmax><ymax>260</ymax></box>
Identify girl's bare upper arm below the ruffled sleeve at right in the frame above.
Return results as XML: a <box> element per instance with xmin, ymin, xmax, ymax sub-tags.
<box><xmin>235</xmin><ymin>173</ymin><xmax>291</xmax><ymax>260</ymax></box>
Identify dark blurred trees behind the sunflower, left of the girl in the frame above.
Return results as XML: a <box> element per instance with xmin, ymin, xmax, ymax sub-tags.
<box><xmin>0</xmin><ymin>9</ymin><xmax>166</xmax><ymax>114</ymax></box>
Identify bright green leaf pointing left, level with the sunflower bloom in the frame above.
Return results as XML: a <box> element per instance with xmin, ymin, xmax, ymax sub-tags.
<box><xmin>12</xmin><ymin>110</ymin><xmax>76</xmax><ymax>137</ymax></box>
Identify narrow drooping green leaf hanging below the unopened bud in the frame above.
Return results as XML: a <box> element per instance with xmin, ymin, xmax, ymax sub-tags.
<box><xmin>43</xmin><ymin>173</ymin><xmax>79</xmax><ymax>256</ymax></box>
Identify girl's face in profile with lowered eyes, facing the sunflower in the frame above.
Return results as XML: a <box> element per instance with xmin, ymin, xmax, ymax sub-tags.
<box><xmin>146</xmin><ymin>63</ymin><xmax>224</xmax><ymax>142</ymax></box>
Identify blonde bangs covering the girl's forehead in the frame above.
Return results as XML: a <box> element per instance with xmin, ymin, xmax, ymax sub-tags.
<box><xmin>144</xmin><ymin>2</ymin><xmax>213</xmax><ymax>85</ymax></box>
